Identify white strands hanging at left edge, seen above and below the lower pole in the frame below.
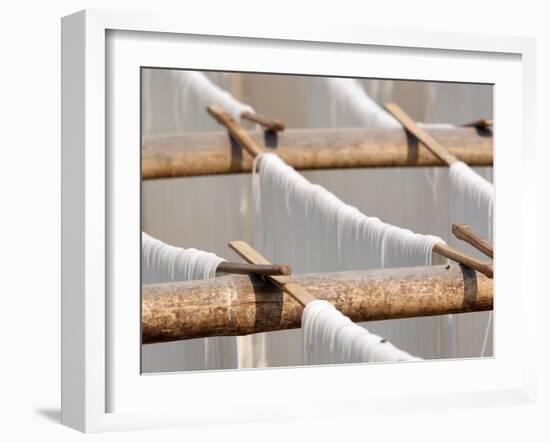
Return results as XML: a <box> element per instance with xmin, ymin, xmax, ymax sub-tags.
<box><xmin>141</xmin><ymin>232</ymin><xmax>237</xmax><ymax>372</ymax></box>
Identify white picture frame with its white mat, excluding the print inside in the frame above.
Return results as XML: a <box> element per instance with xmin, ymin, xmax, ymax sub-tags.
<box><xmin>62</xmin><ymin>10</ymin><xmax>536</xmax><ymax>432</ymax></box>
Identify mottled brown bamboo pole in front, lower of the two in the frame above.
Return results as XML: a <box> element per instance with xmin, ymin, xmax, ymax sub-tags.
<box><xmin>142</xmin><ymin>264</ymin><xmax>493</xmax><ymax>343</ymax></box>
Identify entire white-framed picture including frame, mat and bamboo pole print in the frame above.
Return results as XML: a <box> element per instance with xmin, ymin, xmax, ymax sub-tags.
<box><xmin>62</xmin><ymin>11</ymin><xmax>535</xmax><ymax>432</ymax></box>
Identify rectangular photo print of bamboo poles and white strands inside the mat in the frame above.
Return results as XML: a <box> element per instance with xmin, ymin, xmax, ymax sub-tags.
<box><xmin>140</xmin><ymin>67</ymin><xmax>494</xmax><ymax>374</ymax></box>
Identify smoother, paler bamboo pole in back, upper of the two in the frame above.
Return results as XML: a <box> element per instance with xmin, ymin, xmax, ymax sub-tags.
<box><xmin>142</xmin><ymin>127</ymin><xmax>493</xmax><ymax>180</ymax></box>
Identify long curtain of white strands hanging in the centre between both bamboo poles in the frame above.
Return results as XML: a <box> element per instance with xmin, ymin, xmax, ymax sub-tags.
<box><xmin>253</xmin><ymin>153</ymin><xmax>443</xmax><ymax>271</ymax></box>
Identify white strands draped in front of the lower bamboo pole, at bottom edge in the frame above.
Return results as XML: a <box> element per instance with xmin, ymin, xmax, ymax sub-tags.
<box><xmin>302</xmin><ymin>300</ymin><xmax>420</xmax><ymax>365</ymax></box>
